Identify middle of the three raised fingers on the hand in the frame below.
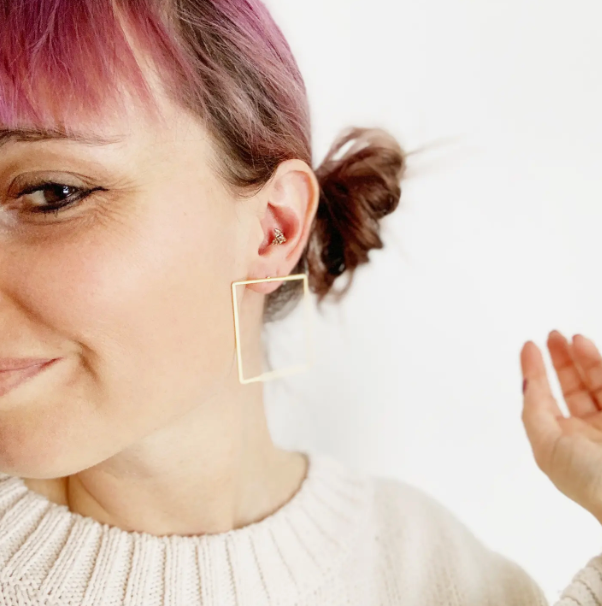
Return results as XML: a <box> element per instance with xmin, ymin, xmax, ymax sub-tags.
<box><xmin>548</xmin><ymin>330</ymin><xmax>599</xmax><ymax>417</ymax></box>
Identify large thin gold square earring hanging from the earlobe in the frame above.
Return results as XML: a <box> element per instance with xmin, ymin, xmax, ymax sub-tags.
<box><xmin>232</xmin><ymin>274</ymin><xmax>314</xmax><ymax>384</ymax></box>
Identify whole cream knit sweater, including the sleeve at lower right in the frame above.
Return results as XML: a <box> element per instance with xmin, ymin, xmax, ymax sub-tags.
<box><xmin>0</xmin><ymin>452</ymin><xmax>602</xmax><ymax>606</ymax></box>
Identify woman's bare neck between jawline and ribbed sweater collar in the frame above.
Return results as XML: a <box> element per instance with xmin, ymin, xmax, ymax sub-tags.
<box><xmin>26</xmin><ymin>376</ymin><xmax>307</xmax><ymax>536</ymax></box>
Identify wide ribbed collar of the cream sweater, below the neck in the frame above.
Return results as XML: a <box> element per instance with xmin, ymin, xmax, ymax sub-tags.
<box><xmin>0</xmin><ymin>451</ymin><xmax>372</xmax><ymax>606</ymax></box>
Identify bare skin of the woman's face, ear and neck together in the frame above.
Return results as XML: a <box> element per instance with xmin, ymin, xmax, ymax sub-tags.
<box><xmin>0</xmin><ymin>64</ymin><xmax>319</xmax><ymax>536</ymax></box>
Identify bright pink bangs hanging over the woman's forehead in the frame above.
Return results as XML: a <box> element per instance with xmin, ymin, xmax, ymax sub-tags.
<box><xmin>0</xmin><ymin>0</ymin><xmax>195</xmax><ymax>130</ymax></box>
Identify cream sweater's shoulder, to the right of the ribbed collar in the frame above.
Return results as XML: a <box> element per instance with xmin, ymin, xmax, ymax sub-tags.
<box><xmin>364</xmin><ymin>475</ymin><xmax>548</xmax><ymax>606</ymax></box>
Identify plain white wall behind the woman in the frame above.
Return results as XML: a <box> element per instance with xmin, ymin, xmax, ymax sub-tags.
<box><xmin>266</xmin><ymin>0</ymin><xmax>602</xmax><ymax>602</ymax></box>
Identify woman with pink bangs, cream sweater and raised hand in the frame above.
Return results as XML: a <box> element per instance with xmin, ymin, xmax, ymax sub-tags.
<box><xmin>0</xmin><ymin>0</ymin><xmax>602</xmax><ymax>606</ymax></box>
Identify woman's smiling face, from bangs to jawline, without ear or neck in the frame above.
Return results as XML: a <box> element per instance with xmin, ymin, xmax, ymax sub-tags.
<box><xmin>0</xmin><ymin>90</ymin><xmax>274</xmax><ymax>478</ymax></box>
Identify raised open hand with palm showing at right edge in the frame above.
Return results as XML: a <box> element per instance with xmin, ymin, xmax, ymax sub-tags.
<box><xmin>521</xmin><ymin>331</ymin><xmax>602</xmax><ymax>522</ymax></box>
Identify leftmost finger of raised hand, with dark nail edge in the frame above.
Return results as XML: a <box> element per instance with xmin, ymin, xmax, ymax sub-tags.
<box><xmin>520</xmin><ymin>341</ymin><xmax>564</xmax><ymax>467</ymax></box>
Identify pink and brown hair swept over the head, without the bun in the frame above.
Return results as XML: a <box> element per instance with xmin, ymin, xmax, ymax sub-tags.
<box><xmin>0</xmin><ymin>0</ymin><xmax>311</xmax><ymax>187</ymax></box>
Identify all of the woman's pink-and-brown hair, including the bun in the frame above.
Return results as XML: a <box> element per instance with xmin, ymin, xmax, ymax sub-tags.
<box><xmin>0</xmin><ymin>0</ymin><xmax>405</xmax><ymax>319</ymax></box>
